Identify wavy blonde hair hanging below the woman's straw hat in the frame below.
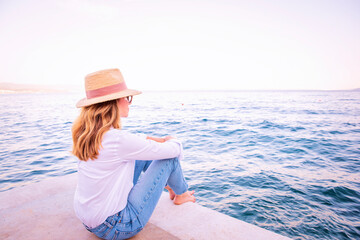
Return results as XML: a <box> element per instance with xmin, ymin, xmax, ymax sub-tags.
<box><xmin>72</xmin><ymin>100</ymin><xmax>121</xmax><ymax>161</ymax></box>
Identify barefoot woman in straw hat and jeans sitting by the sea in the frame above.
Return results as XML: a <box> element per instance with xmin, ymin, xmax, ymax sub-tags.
<box><xmin>72</xmin><ymin>69</ymin><xmax>195</xmax><ymax>239</ymax></box>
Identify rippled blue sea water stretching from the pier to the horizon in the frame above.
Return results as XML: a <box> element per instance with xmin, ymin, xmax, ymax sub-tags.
<box><xmin>0</xmin><ymin>91</ymin><xmax>360</xmax><ymax>239</ymax></box>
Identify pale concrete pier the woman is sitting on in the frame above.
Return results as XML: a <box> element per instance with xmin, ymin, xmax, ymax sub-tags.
<box><xmin>0</xmin><ymin>174</ymin><xmax>290</xmax><ymax>240</ymax></box>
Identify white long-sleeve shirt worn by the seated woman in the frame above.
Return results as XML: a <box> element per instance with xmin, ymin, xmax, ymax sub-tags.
<box><xmin>74</xmin><ymin>128</ymin><xmax>182</xmax><ymax>228</ymax></box>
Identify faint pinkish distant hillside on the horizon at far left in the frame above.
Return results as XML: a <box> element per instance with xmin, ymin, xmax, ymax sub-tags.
<box><xmin>0</xmin><ymin>82</ymin><xmax>79</xmax><ymax>93</ymax></box>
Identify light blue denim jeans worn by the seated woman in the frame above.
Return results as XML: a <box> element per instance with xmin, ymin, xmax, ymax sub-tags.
<box><xmin>85</xmin><ymin>158</ymin><xmax>188</xmax><ymax>239</ymax></box>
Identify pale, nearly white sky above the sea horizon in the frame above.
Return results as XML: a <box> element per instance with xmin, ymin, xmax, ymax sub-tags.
<box><xmin>0</xmin><ymin>0</ymin><xmax>360</xmax><ymax>90</ymax></box>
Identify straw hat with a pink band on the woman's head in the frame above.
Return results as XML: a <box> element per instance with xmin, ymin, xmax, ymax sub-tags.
<box><xmin>76</xmin><ymin>68</ymin><xmax>141</xmax><ymax>108</ymax></box>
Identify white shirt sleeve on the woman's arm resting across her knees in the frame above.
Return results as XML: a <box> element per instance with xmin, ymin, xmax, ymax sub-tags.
<box><xmin>118</xmin><ymin>132</ymin><xmax>182</xmax><ymax>160</ymax></box>
